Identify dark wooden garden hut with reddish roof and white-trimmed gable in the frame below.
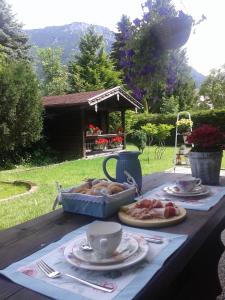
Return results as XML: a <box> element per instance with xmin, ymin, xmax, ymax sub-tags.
<box><xmin>43</xmin><ymin>86</ymin><xmax>143</xmax><ymax>159</ymax></box>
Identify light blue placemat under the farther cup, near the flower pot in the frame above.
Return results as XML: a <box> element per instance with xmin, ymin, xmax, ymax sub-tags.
<box><xmin>141</xmin><ymin>182</ymin><xmax>225</xmax><ymax>211</ymax></box>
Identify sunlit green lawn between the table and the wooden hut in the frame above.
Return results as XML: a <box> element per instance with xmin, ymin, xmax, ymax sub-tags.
<box><xmin>0</xmin><ymin>146</ymin><xmax>225</xmax><ymax>229</ymax></box>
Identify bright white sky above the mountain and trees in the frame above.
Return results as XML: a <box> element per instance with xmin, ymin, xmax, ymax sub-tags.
<box><xmin>6</xmin><ymin>0</ymin><xmax>225</xmax><ymax>75</ymax></box>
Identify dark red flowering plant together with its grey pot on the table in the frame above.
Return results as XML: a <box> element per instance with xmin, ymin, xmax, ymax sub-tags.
<box><xmin>187</xmin><ymin>124</ymin><xmax>225</xmax><ymax>185</ymax></box>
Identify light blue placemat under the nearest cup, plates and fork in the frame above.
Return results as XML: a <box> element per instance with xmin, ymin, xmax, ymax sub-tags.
<box><xmin>0</xmin><ymin>226</ymin><xmax>187</xmax><ymax>300</ymax></box>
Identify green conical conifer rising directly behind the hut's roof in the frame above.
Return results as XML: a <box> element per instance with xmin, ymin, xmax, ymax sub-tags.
<box><xmin>69</xmin><ymin>26</ymin><xmax>121</xmax><ymax>92</ymax></box>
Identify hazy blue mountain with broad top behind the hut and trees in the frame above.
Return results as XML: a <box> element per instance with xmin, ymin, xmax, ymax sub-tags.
<box><xmin>25</xmin><ymin>22</ymin><xmax>115</xmax><ymax>63</ymax></box>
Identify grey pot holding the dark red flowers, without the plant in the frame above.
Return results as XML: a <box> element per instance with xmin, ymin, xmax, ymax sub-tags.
<box><xmin>188</xmin><ymin>151</ymin><xmax>223</xmax><ymax>185</ymax></box>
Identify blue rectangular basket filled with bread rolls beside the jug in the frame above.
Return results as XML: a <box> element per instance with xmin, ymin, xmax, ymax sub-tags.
<box><xmin>55</xmin><ymin>179</ymin><xmax>136</xmax><ymax>218</ymax></box>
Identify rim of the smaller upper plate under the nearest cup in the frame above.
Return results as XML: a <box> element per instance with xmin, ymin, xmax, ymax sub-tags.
<box><xmin>72</xmin><ymin>231</ymin><xmax>139</xmax><ymax>265</ymax></box>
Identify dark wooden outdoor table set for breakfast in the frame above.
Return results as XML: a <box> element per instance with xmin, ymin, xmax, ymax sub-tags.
<box><xmin>0</xmin><ymin>173</ymin><xmax>225</xmax><ymax>300</ymax></box>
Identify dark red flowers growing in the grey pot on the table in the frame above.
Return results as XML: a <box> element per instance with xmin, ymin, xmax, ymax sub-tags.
<box><xmin>187</xmin><ymin>124</ymin><xmax>225</xmax><ymax>152</ymax></box>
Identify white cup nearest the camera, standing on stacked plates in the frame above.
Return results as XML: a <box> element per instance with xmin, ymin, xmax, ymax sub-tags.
<box><xmin>86</xmin><ymin>221</ymin><xmax>122</xmax><ymax>258</ymax></box>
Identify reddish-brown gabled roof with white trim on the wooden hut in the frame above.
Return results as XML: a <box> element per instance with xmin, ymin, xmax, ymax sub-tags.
<box><xmin>43</xmin><ymin>86</ymin><xmax>143</xmax><ymax>109</ymax></box>
